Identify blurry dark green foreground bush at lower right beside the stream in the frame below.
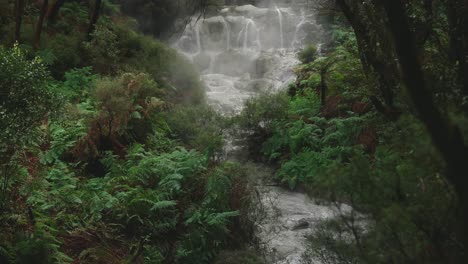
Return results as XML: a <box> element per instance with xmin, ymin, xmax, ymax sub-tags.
<box><xmin>300</xmin><ymin>116</ymin><xmax>456</xmax><ymax>263</ymax></box>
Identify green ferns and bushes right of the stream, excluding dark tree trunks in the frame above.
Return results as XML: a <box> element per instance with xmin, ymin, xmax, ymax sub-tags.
<box><xmin>257</xmin><ymin>16</ymin><xmax>465</xmax><ymax>263</ymax></box>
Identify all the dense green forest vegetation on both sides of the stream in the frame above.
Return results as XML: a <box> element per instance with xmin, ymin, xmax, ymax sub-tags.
<box><xmin>0</xmin><ymin>0</ymin><xmax>468</xmax><ymax>264</ymax></box>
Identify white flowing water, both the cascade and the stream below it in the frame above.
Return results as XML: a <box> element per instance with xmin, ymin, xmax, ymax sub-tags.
<box><xmin>175</xmin><ymin>0</ymin><xmax>344</xmax><ymax>264</ymax></box>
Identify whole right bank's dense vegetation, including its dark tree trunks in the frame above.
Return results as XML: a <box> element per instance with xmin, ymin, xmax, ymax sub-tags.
<box><xmin>241</xmin><ymin>1</ymin><xmax>468</xmax><ymax>263</ymax></box>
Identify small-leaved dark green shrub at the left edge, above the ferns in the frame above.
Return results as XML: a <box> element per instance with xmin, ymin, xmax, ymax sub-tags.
<box><xmin>0</xmin><ymin>46</ymin><xmax>59</xmax><ymax>153</ymax></box>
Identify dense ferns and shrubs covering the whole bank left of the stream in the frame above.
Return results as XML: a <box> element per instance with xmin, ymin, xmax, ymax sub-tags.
<box><xmin>0</xmin><ymin>1</ymin><xmax>260</xmax><ymax>263</ymax></box>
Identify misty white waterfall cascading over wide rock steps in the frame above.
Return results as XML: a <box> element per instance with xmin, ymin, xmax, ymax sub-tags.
<box><xmin>175</xmin><ymin>1</ymin><xmax>319</xmax><ymax>112</ymax></box>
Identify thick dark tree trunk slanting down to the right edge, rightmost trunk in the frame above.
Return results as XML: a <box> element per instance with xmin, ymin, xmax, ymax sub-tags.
<box><xmin>382</xmin><ymin>0</ymin><xmax>468</xmax><ymax>263</ymax></box>
